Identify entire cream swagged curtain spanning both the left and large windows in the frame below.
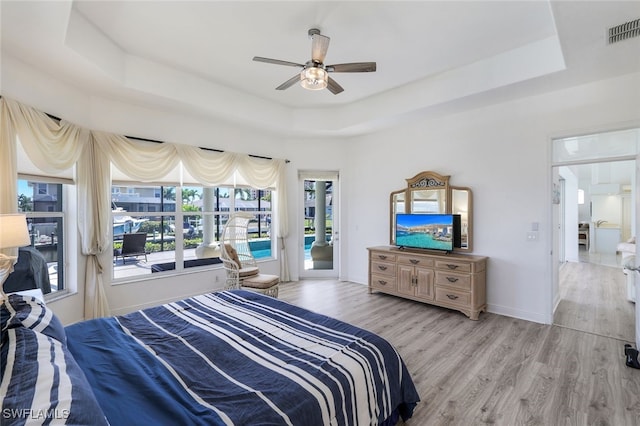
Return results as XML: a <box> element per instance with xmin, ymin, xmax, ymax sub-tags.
<box><xmin>0</xmin><ymin>97</ymin><xmax>289</xmax><ymax>319</ymax></box>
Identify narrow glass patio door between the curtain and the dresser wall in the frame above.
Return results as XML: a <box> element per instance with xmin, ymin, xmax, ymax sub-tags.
<box><xmin>299</xmin><ymin>171</ymin><xmax>339</xmax><ymax>278</ymax></box>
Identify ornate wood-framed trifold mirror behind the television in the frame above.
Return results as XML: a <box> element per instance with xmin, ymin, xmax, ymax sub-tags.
<box><xmin>389</xmin><ymin>171</ymin><xmax>473</xmax><ymax>252</ymax></box>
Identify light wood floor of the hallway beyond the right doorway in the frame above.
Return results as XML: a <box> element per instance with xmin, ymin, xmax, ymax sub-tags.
<box><xmin>553</xmin><ymin>262</ymin><xmax>635</xmax><ymax>342</ymax></box>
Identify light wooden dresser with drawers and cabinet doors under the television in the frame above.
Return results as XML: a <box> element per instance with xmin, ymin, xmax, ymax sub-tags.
<box><xmin>367</xmin><ymin>246</ymin><xmax>487</xmax><ymax>320</ymax></box>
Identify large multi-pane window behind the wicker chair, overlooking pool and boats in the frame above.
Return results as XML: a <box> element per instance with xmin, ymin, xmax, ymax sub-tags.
<box><xmin>111</xmin><ymin>184</ymin><xmax>273</xmax><ymax>280</ymax></box>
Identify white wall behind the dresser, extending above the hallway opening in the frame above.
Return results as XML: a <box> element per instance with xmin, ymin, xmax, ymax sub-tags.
<box><xmin>344</xmin><ymin>74</ymin><xmax>640</xmax><ymax>323</ymax></box>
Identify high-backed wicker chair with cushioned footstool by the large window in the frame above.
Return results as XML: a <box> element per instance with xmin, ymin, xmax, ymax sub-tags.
<box><xmin>220</xmin><ymin>212</ymin><xmax>280</xmax><ymax>298</ymax></box>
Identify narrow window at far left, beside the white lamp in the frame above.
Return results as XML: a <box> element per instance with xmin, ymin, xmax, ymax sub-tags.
<box><xmin>18</xmin><ymin>179</ymin><xmax>66</xmax><ymax>293</ymax></box>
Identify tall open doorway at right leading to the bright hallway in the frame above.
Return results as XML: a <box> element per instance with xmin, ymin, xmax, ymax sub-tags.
<box><xmin>553</xmin><ymin>129</ymin><xmax>640</xmax><ymax>343</ymax></box>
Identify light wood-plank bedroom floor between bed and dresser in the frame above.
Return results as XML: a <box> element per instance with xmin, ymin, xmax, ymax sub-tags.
<box><xmin>279</xmin><ymin>280</ymin><xmax>640</xmax><ymax>426</ymax></box>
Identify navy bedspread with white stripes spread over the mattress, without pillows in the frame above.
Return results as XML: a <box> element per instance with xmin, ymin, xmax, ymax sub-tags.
<box><xmin>66</xmin><ymin>291</ymin><xmax>419</xmax><ymax>426</ymax></box>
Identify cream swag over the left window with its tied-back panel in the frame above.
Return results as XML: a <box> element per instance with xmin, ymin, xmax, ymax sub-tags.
<box><xmin>0</xmin><ymin>98</ymin><xmax>110</xmax><ymax>319</ymax></box>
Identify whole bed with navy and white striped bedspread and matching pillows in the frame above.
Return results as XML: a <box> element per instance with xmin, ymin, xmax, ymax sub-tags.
<box><xmin>0</xmin><ymin>290</ymin><xmax>419</xmax><ymax>425</ymax></box>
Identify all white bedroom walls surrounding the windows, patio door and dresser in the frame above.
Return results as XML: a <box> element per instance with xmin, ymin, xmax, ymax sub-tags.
<box><xmin>2</xmin><ymin>51</ymin><xmax>640</xmax><ymax>323</ymax></box>
